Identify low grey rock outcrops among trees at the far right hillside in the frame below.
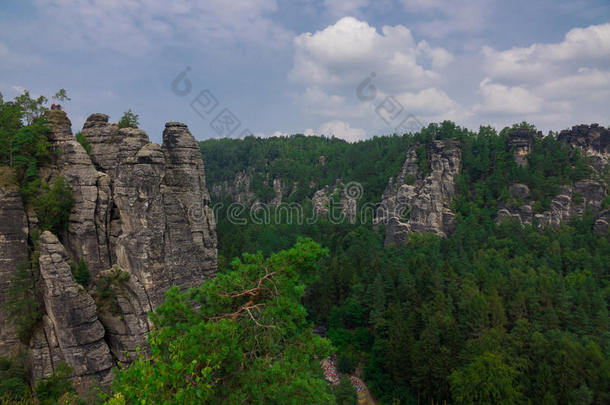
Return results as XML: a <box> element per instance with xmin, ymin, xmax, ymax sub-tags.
<box><xmin>496</xmin><ymin>180</ymin><xmax>607</xmax><ymax>230</ymax></box>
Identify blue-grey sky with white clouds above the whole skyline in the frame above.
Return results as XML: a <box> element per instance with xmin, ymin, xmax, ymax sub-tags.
<box><xmin>0</xmin><ymin>0</ymin><xmax>610</xmax><ymax>141</ymax></box>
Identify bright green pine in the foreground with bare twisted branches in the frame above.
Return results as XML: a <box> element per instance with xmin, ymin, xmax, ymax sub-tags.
<box><xmin>114</xmin><ymin>240</ymin><xmax>334</xmax><ymax>404</ymax></box>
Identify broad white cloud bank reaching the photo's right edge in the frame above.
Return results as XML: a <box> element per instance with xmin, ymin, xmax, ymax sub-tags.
<box><xmin>475</xmin><ymin>24</ymin><xmax>610</xmax><ymax>128</ymax></box>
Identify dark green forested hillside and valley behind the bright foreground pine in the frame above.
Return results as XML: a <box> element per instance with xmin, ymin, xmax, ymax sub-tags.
<box><xmin>200</xmin><ymin>122</ymin><xmax>610</xmax><ymax>404</ymax></box>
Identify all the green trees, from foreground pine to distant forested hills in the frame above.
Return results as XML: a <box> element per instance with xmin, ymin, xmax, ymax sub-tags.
<box><xmin>0</xmin><ymin>87</ymin><xmax>610</xmax><ymax>405</ymax></box>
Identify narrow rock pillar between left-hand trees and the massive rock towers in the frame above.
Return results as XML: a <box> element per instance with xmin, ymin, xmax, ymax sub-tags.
<box><xmin>45</xmin><ymin>110</ymin><xmax>111</xmax><ymax>275</ymax></box>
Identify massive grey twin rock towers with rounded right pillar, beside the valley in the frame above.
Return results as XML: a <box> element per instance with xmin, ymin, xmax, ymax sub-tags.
<box><xmin>72</xmin><ymin>114</ymin><xmax>216</xmax><ymax>361</ymax></box>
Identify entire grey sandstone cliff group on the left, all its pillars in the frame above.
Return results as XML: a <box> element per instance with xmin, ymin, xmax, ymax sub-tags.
<box><xmin>0</xmin><ymin>110</ymin><xmax>217</xmax><ymax>391</ymax></box>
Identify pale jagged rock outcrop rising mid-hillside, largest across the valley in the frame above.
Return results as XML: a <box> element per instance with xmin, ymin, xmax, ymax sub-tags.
<box><xmin>375</xmin><ymin>139</ymin><xmax>462</xmax><ymax>245</ymax></box>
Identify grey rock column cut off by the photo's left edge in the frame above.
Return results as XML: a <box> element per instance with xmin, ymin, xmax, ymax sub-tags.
<box><xmin>0</xmin><ymin>167</ymin><xmax>28</xmax><ymax>357</ymax></box>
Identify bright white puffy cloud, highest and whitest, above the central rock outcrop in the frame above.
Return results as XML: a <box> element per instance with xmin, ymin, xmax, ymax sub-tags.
<box><xmin>290</xmin><ymin>17</ymin><xmax>451</xmax><ymax>91</ymax></box>
